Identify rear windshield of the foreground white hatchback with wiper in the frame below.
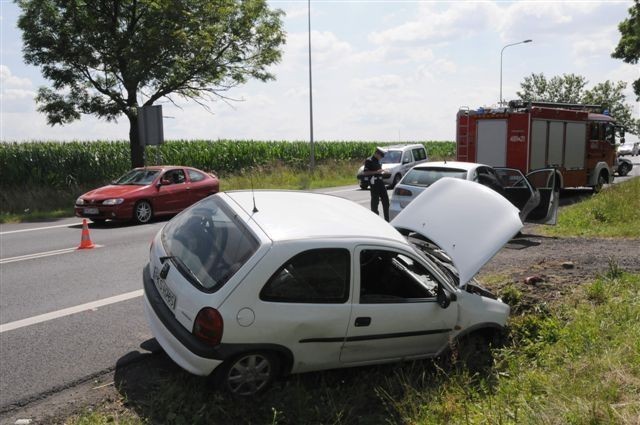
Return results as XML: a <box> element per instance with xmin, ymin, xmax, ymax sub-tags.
<box><xmin>162</xmin><ymin>196</ymin><xmax>259</xmax><ymax>292</ymax></box>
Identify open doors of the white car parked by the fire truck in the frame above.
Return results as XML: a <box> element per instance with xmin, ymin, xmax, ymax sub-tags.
<box><xmin>495</xmin><ymin>168</ymin><xmax>560</xmax><ymax>224</ymax></box>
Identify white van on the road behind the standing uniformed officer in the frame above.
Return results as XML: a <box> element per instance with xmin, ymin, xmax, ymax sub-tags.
<box><xmin>356</xmin><ymin>144</ymin><xmax>429</xmax><ymax>189</ymax></box>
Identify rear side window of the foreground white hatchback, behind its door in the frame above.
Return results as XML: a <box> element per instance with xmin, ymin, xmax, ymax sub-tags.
<box><xmin>260</xmin><ymin>248</ymin><xmax>351</xmax><ymax>304</ymax></box>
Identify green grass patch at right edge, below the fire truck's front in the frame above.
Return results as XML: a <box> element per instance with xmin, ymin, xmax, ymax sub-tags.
<box><xmin>540</xmin><ymin>178</ymin><xmax>640</xmax><ymax>238</ymax></box>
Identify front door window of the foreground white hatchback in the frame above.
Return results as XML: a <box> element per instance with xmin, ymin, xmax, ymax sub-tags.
<box><xmin>360</xmin><ymin>249</ymin><xmax>438</xmax><ymax>304</ymax></box>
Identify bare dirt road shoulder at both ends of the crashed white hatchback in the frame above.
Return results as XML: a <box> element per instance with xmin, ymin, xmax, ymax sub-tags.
<box><xmin>0</xmin><ymin>226</ymin><xmax>640</xmax><ymax>425</ymax></box>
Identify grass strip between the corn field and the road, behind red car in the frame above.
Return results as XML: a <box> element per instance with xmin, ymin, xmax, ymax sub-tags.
<box><xmin>0</xmin><ymin>160</ymin><xmax>362</xmax><ymax>223</ymax></box>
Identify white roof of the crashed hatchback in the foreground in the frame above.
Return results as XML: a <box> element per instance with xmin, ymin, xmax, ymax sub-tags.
<box><xmin>219</xmin><ymin>190</ymin><xmax>407</xmax><ymax>243</ymax></box>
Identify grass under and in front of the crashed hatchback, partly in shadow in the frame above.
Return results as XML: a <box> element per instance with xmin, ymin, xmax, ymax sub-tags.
<box><xmin>65</xmin><ymin>264</ymin><xmax>640</xmax><ymax>425</ymax></box>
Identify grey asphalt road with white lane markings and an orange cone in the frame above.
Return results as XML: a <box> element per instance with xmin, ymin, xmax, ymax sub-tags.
<box><xmin>0</xmin><ymin>156</ymin><xmax>640</xmax><ymax>413</ymax></box>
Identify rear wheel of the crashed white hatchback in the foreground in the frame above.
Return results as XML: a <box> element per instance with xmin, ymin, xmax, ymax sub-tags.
<box><xmin>214</xmin><ymin>352</ymin><xmax>280</xmax><ymax>397</ymax></box>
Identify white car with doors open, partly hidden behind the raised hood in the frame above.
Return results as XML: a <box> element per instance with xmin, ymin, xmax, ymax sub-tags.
<box><xmin>389</xmin><ymin>161</ymin><xmax>559</xmax><ymax>224</ymax></box>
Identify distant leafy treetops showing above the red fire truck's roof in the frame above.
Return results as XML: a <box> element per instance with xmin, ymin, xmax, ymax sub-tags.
<box><xmin>516</xmin><ymin>73</ymin><xmax>640</xmax><ymax>134</ymax></box>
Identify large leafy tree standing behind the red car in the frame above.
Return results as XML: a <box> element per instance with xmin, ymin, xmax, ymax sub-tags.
<box><xmin>18</xmin><ymin>0</ymin><xmax>285</xmax><ymax>167</ymax></box>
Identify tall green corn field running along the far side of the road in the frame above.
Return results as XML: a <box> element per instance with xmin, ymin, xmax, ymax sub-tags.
<box><xmin>0</xmin><ymin>140</ymin><xmax>455</xmax><ymax>188</ymax></box>
